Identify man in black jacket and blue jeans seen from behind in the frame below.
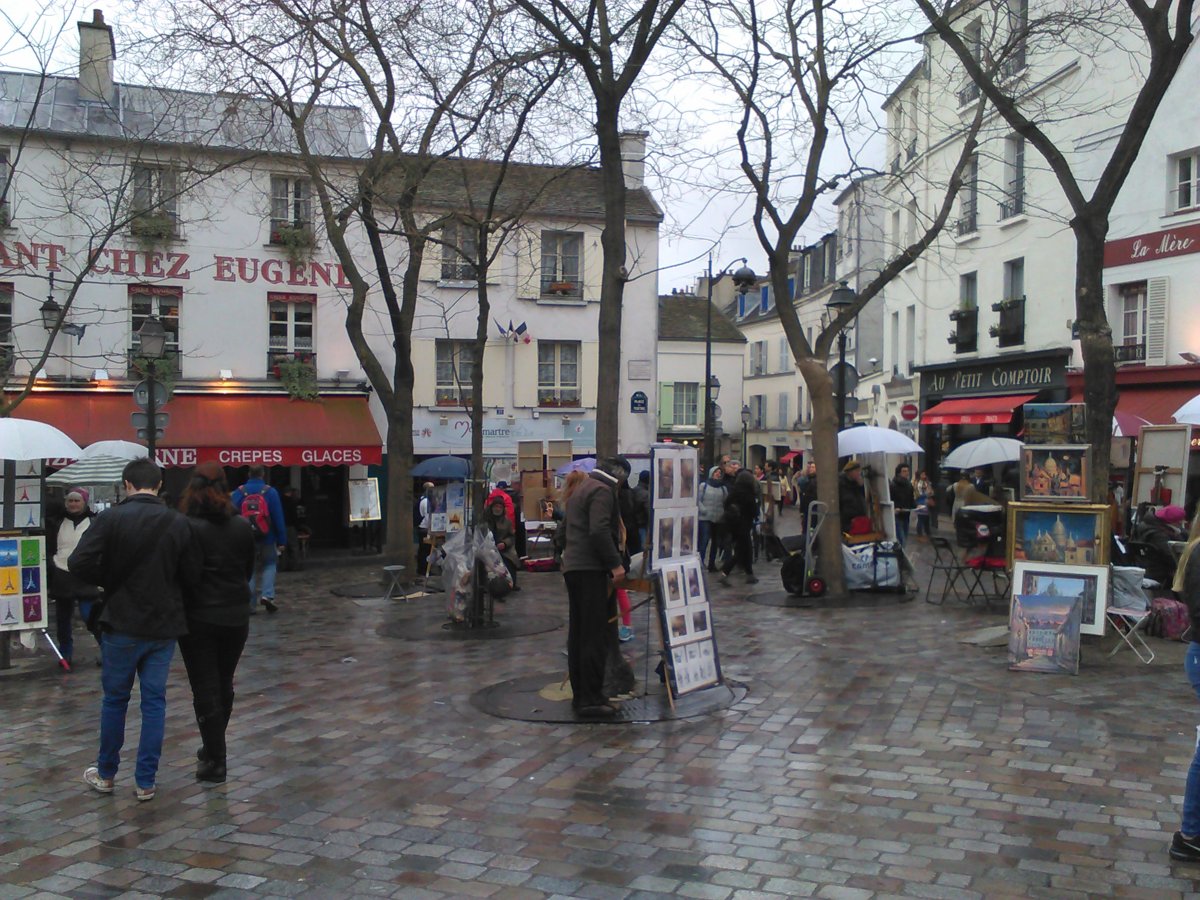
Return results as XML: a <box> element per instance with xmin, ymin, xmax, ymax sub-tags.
<box><xmin>67</xmin><ymin>460</ymin><xmax>200</xmax><ymax>800</ymax></box>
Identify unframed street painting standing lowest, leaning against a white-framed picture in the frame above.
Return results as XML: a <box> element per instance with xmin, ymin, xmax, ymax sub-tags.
<box><xmin>1008</xmin><ymin>594</ymin><xmax>1082</xmax><ymax>674</ymax></box>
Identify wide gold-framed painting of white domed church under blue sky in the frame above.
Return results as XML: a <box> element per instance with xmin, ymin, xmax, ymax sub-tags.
<box><xmin>1006</xmin><ymin>500</ymin><xmax>1112</xmax><ymax>569</ymax></box>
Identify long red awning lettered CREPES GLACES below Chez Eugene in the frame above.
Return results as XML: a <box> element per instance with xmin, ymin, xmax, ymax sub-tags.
<box><xmin>13</xmin><ymin>391</ymin><xmax>383</xmax><ymax>467</ymax></box>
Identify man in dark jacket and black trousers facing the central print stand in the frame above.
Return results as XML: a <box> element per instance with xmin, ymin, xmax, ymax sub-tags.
<box><xmin>563</xmin><ymin>457</ymin><xmax>629</xmax><ymax>719</ymax></box>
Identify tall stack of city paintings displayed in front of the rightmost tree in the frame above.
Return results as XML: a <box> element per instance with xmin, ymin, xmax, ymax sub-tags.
<box><xmin>1007</xmin><ymin>403</ymin><xmax>1111</xmax><ymax>674</ymax></box>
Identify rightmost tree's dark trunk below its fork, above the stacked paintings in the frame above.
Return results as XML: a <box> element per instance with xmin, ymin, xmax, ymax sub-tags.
<box><xmin>1070</xmin><ymin>216</ymin><xmax>1117</xmax><ymax>503</ymax></box>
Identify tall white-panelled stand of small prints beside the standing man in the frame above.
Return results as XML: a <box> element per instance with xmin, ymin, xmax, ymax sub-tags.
<box><xmin>647</xmin><ymin>444</ymin><xmax>724</xmax><ymax>708</ymax></box>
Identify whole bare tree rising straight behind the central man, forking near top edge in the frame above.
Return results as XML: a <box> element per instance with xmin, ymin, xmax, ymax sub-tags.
<box><xmin>515</xmin><ymin>0</ymin><xmax>685</xmax><ymax>456</ymax></box>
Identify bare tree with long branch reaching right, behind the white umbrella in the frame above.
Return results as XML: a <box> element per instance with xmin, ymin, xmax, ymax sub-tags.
<box><xmin>686</xmin><ymin>0</ymin><xmax>983</xmax><ymax>595</ymax></box>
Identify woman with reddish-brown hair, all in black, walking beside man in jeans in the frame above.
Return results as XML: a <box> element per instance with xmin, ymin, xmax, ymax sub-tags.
<box><xmin>179</xmin><ymin>462</ymin><xmax>254</xmax><ymax>784</ymax></box>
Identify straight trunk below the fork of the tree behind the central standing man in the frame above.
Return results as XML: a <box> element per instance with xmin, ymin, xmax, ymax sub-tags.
<box><xmin>596</xmin><ymin>98</ymin><xmax>626</xmax><ymax>458</ymax></box>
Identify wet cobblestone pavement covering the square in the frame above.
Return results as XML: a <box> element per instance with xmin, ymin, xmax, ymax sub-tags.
<box><xmin>0</xmin><ymin>511</ymin><xmax>1200</xmax><ymax>898</ymax></box>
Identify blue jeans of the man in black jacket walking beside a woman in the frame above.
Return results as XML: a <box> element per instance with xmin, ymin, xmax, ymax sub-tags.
<box><xmin>96</xmin><ymin>631</ymin><xmax>175</xmax><ymax>787</ymax></box>
